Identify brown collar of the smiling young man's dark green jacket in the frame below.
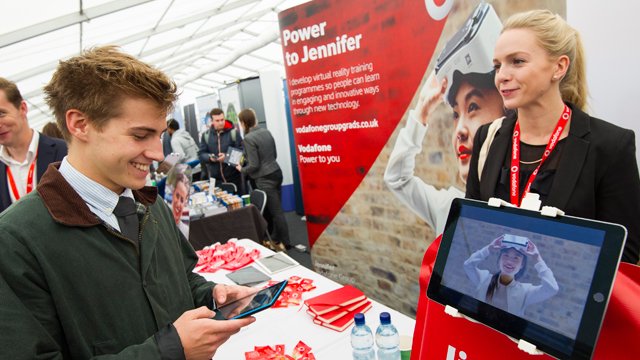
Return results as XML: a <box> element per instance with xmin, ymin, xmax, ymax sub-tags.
<box><xmin>36</xmin><ymin>162</ymin><xmax>158</xmax><ymax>227</ymax></box>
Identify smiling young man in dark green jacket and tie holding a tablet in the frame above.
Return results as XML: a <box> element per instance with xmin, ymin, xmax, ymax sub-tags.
<box><xmin>0</xmin><ymin>46</ymin><xmax>255</xmax><ymax>359</ymax></box>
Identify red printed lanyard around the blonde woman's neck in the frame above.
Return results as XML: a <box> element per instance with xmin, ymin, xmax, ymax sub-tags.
<box><xmin>510</xmin><ymin>105</ymin><xmax>571</xmax><ymax>206</ymax></box>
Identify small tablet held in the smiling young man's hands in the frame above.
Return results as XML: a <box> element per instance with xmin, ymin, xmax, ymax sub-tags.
<box><xmin>214</xmin><ymin>280</ymin><xmax>287</xmax><ymax>320</ymax></box>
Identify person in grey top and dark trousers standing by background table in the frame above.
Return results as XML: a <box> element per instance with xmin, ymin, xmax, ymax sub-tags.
<box><xmin>237</xmin><ymin>109</ymin><xmax>291</xmax><ymax>251</ymax></box>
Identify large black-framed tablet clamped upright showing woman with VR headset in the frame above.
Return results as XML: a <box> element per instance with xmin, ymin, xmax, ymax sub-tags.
<box><xmin>427</xmin><ymin>199</ymin><xmax>626</xmax><ymax>358</ymax></box>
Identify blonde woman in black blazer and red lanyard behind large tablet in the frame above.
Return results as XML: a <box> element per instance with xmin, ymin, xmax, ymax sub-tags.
<box><xmin>466</xmin><ymin>10</ymin><xmax>640</xmax><ymax>264</ymax></box>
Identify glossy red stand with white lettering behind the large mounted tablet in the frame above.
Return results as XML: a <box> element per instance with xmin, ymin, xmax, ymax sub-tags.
<box><xmin>411</xmin><ymin>236</ymin><xmax>640</xmax><ymax>360</ymax></box>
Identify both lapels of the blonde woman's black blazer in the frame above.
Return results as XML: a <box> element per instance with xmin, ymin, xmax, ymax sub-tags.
<box><xmin>480</xmin><ymin>103</ymin><xmax>591</xmax><ymax>210</ymax></box>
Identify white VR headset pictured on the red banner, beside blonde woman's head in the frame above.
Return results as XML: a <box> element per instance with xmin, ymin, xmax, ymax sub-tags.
<box><xmin>435</xmin><ymin>2</ymin><xmax>502</xmax><ymax>105</ymax></box>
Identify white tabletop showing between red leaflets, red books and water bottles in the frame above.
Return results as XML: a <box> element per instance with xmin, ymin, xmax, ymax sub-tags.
<box><xmin>201</xmin><ymin>239</ymin><xmax>415</xmax><ymax>360</ymax></box>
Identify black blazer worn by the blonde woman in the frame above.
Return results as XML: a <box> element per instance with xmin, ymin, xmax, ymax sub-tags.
<box><xmin>466</xmin><ymin>104</ymin><xmax>640</xmax><ymax>264</ymax></box>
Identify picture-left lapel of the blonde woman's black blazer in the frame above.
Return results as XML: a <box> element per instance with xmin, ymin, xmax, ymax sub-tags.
<box><xmin>480</xmin><ymin>117</ymin><xmax>515</xmax><ymax>200</ymax></box>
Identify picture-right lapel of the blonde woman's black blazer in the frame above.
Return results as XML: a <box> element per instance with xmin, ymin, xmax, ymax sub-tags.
<box><xmin>547</xmin><ymin>105</ymin><xmax>591</xmax><ymax>210</ymax></box>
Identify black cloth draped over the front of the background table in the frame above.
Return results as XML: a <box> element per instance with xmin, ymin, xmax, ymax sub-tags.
<box><xmin>189</xmin><ymin>205</ymin><xmax>267</xmax><ymax>250</ymax></box>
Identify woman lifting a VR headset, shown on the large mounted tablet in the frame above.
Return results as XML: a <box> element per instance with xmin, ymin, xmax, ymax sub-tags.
<box><xmin>464</xmin><ymin>234</ymin><xmax>558</xmax><ymax>316</ymax></box>
